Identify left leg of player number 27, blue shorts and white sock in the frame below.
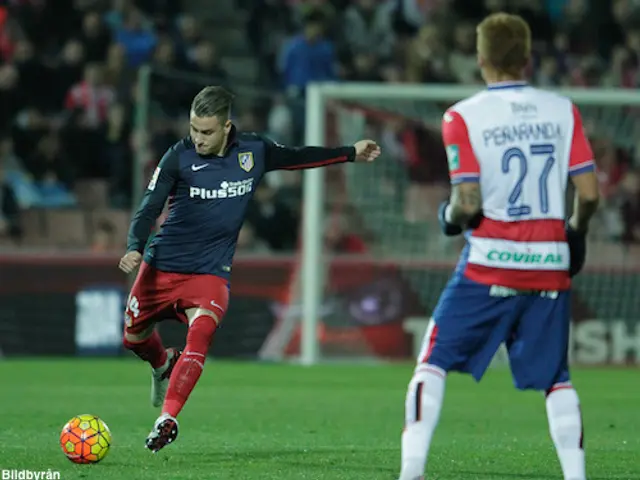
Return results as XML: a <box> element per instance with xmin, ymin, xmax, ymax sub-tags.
<box><xmin>400</xmin><ymin>280</ymin><xmax>518</xmax><ymax>480</ymax></box>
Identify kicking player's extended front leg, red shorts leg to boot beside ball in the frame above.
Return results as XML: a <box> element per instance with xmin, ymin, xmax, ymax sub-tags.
<box><xmin>147</xmin><ymin>275</ymin><xmax>229</xmax><ymax>452</ymax></box>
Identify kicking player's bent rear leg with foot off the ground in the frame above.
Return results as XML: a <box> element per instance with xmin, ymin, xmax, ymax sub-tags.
<box><xmin>122</xmin><ymin>263</ymin><xmax>180</xmax><ymax>407</ymax></box>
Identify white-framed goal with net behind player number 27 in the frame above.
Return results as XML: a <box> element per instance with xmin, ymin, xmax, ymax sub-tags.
<box><xmin>281</xmin><ymin>84</ymin><xmax>640</xmax><ymax>364</ymax></box>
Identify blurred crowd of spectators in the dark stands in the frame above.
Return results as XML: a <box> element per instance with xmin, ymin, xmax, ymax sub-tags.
<box><xmin>0</xmin><ymin>0</ymin><xmax>640</xmax><ymax>253</ymax></box>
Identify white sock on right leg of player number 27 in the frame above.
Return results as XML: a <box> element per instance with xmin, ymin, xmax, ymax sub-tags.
<box><xmin>546</xmin><ymin>383</ymin><xmax>586</xmax><ymax>480</ymax></box>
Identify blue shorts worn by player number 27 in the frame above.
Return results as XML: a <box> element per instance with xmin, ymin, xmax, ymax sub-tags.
<box><xmin>418</xmin><ymin>275</ymin><xmax>571</xmax><ymax>390</ymax></box>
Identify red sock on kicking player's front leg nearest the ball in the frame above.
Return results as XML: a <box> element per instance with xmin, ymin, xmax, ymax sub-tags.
<box><xmin>162</xmin><ymin>315</ymin><xmax>217</xmax><ymax>417</ymax></box>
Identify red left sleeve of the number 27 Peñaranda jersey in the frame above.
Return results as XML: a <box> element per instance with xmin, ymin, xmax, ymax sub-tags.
<box><xmin>442</xmin><ymin>110</ymin><xmax>480</xmax><ymax>185</ymax></box>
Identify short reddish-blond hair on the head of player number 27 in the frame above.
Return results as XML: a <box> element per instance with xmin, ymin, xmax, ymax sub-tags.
<box><xmin>477</xmin><ymin>13</ymin><xmax>531</xmax><ymax>76</ymax></box>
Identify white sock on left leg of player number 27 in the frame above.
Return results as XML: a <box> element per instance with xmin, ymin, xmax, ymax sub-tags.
<box><xmin>400</xmin><ymin>364</ymin><xmax>447</xmax><ymax>480</ymax></box>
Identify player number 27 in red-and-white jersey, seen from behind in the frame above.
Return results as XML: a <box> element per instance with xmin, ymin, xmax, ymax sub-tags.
<box><xmin>400</xmin><ymin>13</ymin><xmax>598</xmax><ymax>480</ymax></box>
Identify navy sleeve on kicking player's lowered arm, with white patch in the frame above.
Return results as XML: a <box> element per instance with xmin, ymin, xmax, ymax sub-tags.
<box><xmin>127</xmin><ymin>147</ymin><xmax>180</xmax><ymax>253</ymax></box>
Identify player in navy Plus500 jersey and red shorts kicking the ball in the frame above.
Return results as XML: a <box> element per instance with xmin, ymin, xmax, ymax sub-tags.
<box><xmin>120</xmin><ymin>87</ymin><xmax>380</xmax><ymax>452</ymax></box>
